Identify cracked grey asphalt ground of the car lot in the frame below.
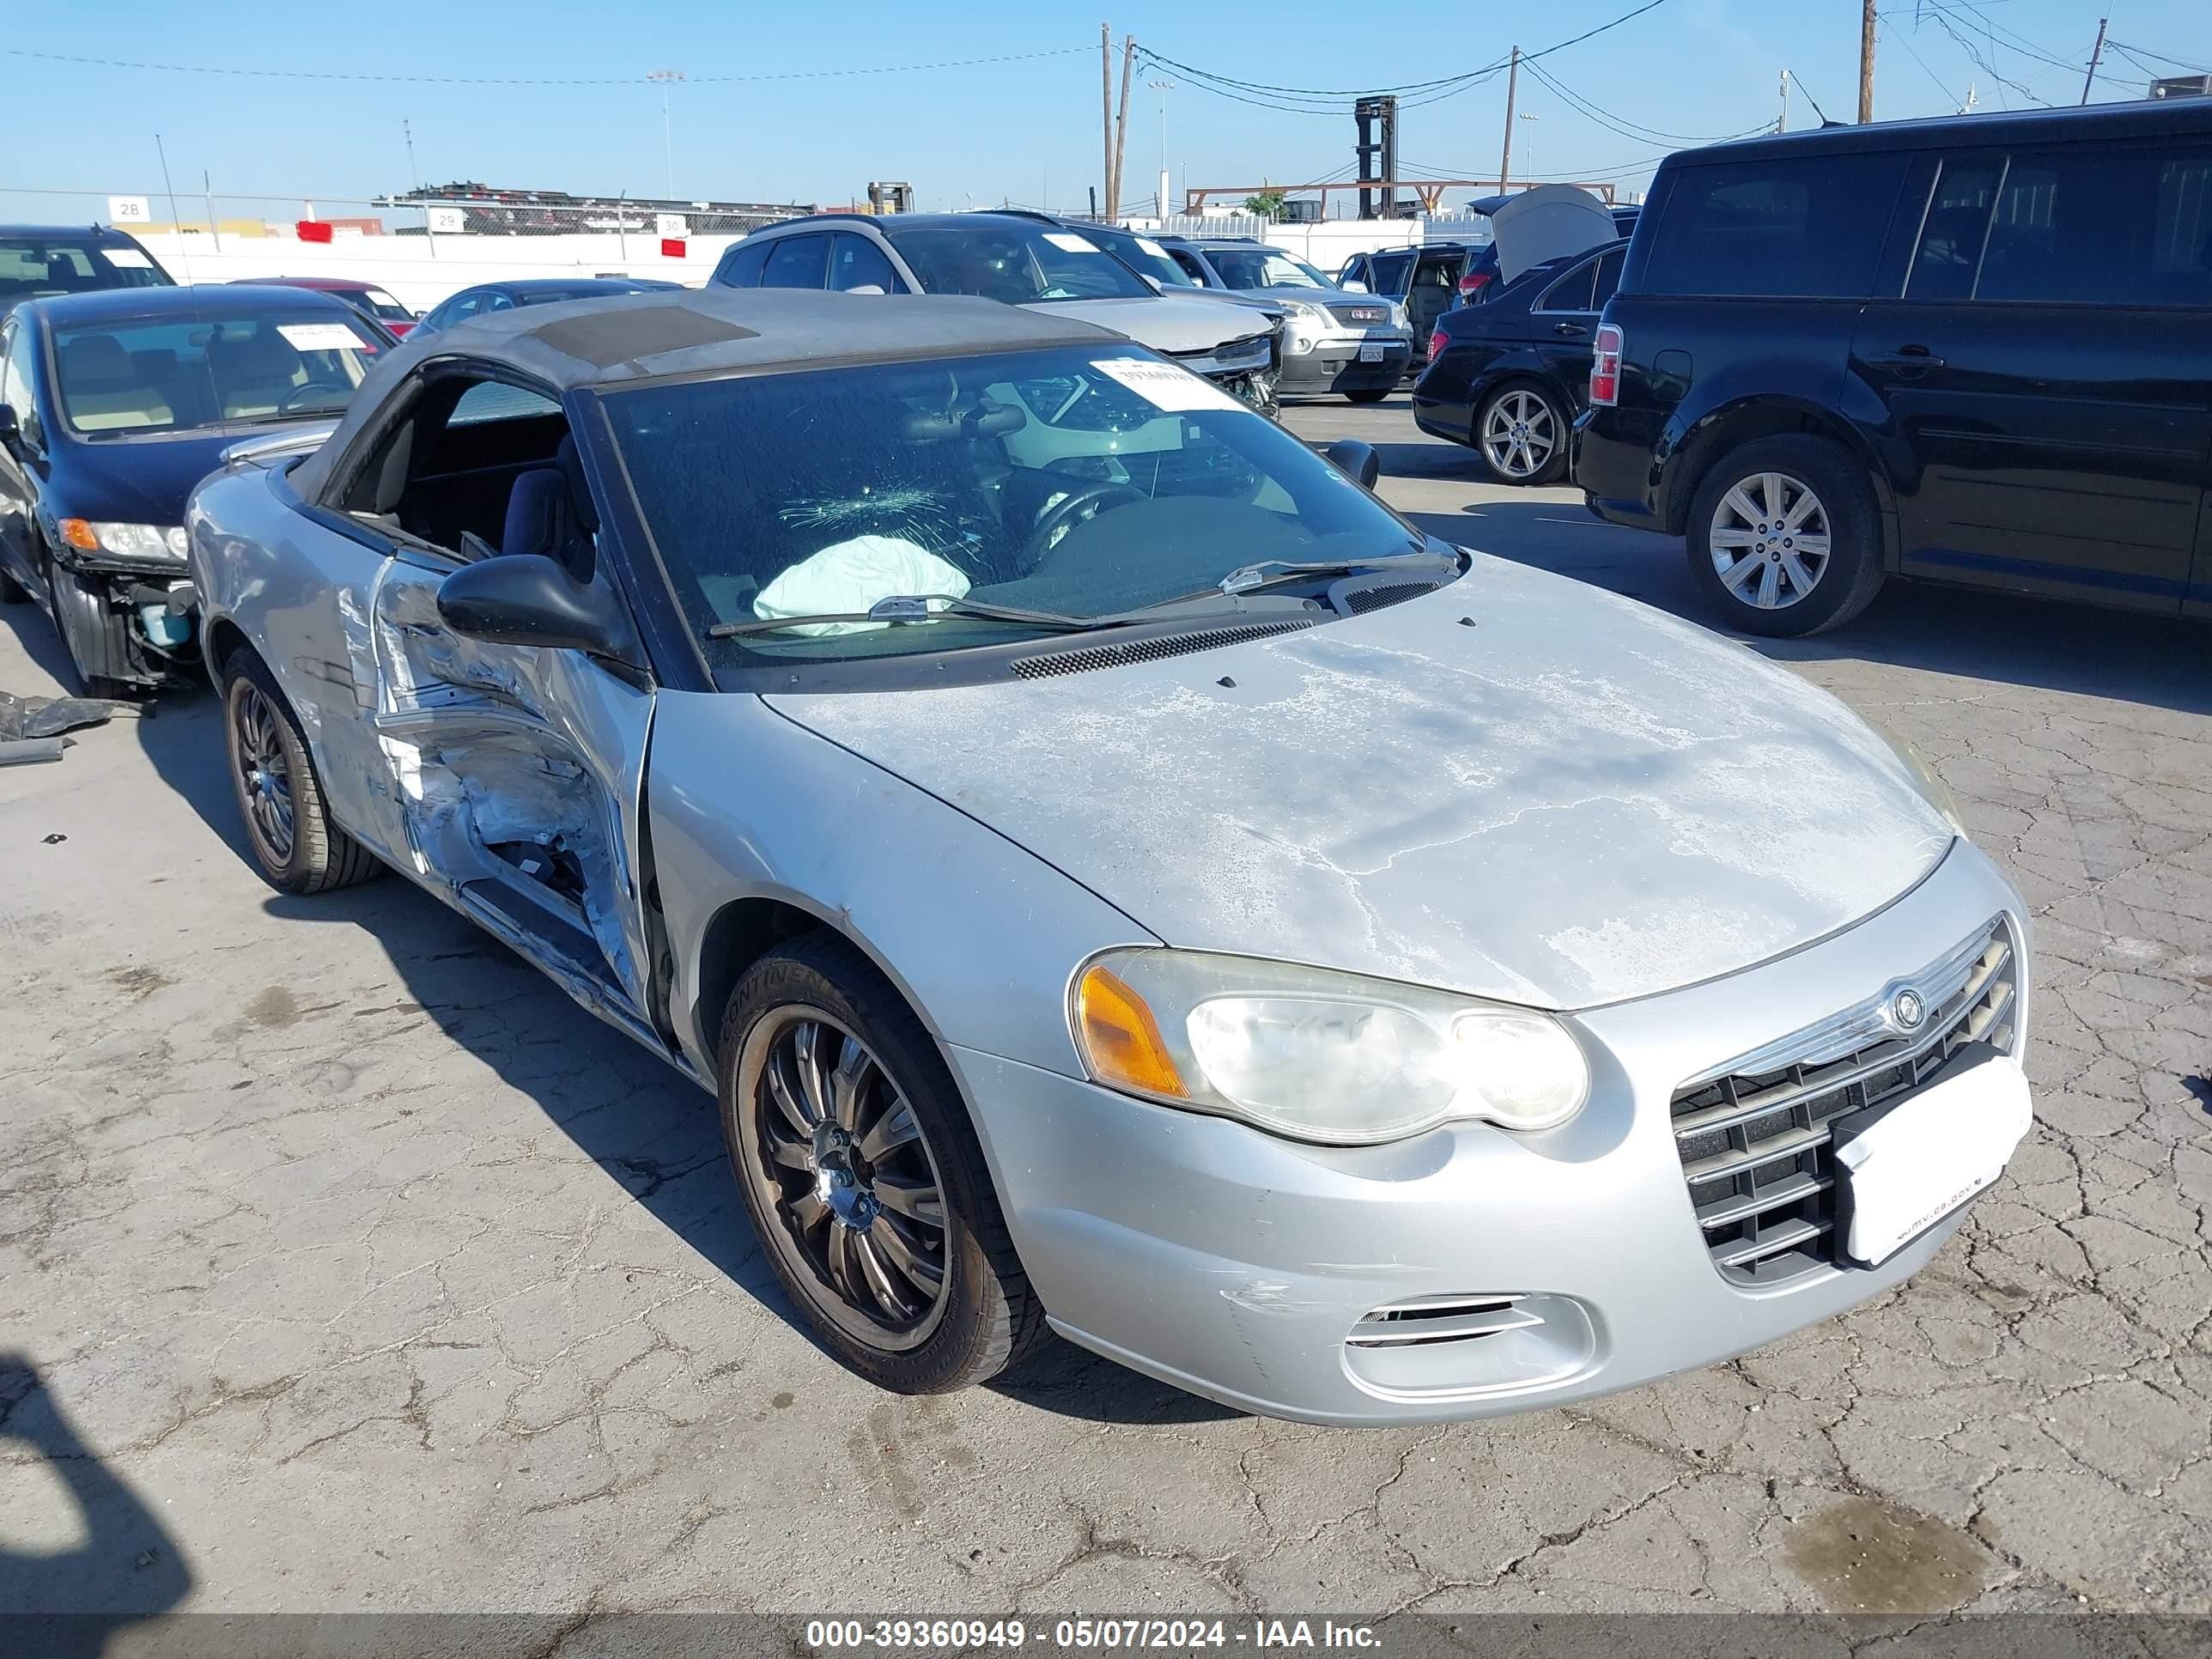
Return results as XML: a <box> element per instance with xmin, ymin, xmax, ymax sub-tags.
<box><xmin>0</xmin><ymin>400</ymin><xmax>2212</xmax><ymax>1614</ymax></box>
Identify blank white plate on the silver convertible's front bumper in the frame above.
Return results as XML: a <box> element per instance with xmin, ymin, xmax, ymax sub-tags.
<box><xmin>1836</xmin><ymin>1055</ymin><xmax>2033</xmax><ymax>1267</ymax></box>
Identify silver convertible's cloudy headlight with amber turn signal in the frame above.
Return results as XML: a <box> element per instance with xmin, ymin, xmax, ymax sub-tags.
<box><xmin>1071</xmin><ymin>949</ymin><xmax>1590</xmax><ymax>1146</ymax></box>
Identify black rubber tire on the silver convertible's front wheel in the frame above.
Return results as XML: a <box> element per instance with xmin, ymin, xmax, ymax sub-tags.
<box><xmin>714</xmin><ymin>931</ymin><xmax>1046</xmax><ymax>1394</ymax></box>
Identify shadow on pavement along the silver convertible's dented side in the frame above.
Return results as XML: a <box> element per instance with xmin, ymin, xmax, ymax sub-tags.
<box><xmin>121</xmin><ymin>690</ymin><xmax>1230</xmax><ymax>1422</ymax></box>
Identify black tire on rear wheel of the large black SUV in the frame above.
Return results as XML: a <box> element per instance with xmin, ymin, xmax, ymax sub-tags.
<box><xmin>1686</xmin><ymin>434</ymin><xmax>1882</xmax><ymax>639</ymax></box>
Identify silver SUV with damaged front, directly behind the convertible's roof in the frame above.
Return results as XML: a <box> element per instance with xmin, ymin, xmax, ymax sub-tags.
<box><xmin>708</xmin><ymin>212</ymin><xmax>1276</xmax><ymax>414</ymax></box>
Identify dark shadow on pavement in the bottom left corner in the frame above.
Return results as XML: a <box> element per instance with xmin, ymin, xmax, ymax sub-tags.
<box><xmin>0</xmin><ymin>1352</ymin><xmax>192</xmax><ymax>1659</ymax></box>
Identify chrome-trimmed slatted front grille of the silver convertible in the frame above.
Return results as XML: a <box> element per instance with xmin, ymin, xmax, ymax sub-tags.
<box><xmin>1672</xmin><ymin>915</ymin><xmax>2020</xmax><ymax>1285</ymax></box>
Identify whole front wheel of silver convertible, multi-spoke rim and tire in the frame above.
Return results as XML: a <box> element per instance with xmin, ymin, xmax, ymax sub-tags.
<box><xmin>717</xmin><ymin>933</ymin><xmax>1044</xmax><ymax>1394</ymax></box>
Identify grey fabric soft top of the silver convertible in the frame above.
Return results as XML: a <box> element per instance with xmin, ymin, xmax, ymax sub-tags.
<box><xmin>292</xmin><ymin>288</ymin><xmax>1121</xmax><ymax>495</ymax></box>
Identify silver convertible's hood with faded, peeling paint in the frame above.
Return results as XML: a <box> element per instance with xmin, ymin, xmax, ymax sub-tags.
<box><xmin>768</xmin><ymin>557</ymin><xmax>1954</xmax><ymax>1009</ymax></box>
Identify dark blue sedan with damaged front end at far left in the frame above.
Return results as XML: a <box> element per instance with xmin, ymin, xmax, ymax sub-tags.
<box><xmin>0</xmin><ymin>283</ymin><xmax>396</xmax><ymax>696</ymax></box>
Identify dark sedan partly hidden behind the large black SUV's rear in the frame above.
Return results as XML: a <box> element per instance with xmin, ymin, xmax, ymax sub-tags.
<box><xmin>1413</xmin><ymin>241</ymin><xmax>1628</xmax><ymax>484</ymax></box>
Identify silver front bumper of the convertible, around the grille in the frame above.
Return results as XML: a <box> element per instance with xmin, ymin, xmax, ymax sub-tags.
<box><xmin>953</xmin><ymin>842</ymin><xmax>2027</xmax><ymax>1425</ymax></box>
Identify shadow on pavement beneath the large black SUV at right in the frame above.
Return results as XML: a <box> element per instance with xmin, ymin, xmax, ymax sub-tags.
<box><xmin>1407</xmin><ymin>500</ymin><xmax>2212</xmax><ymax>714</ymax></box>
